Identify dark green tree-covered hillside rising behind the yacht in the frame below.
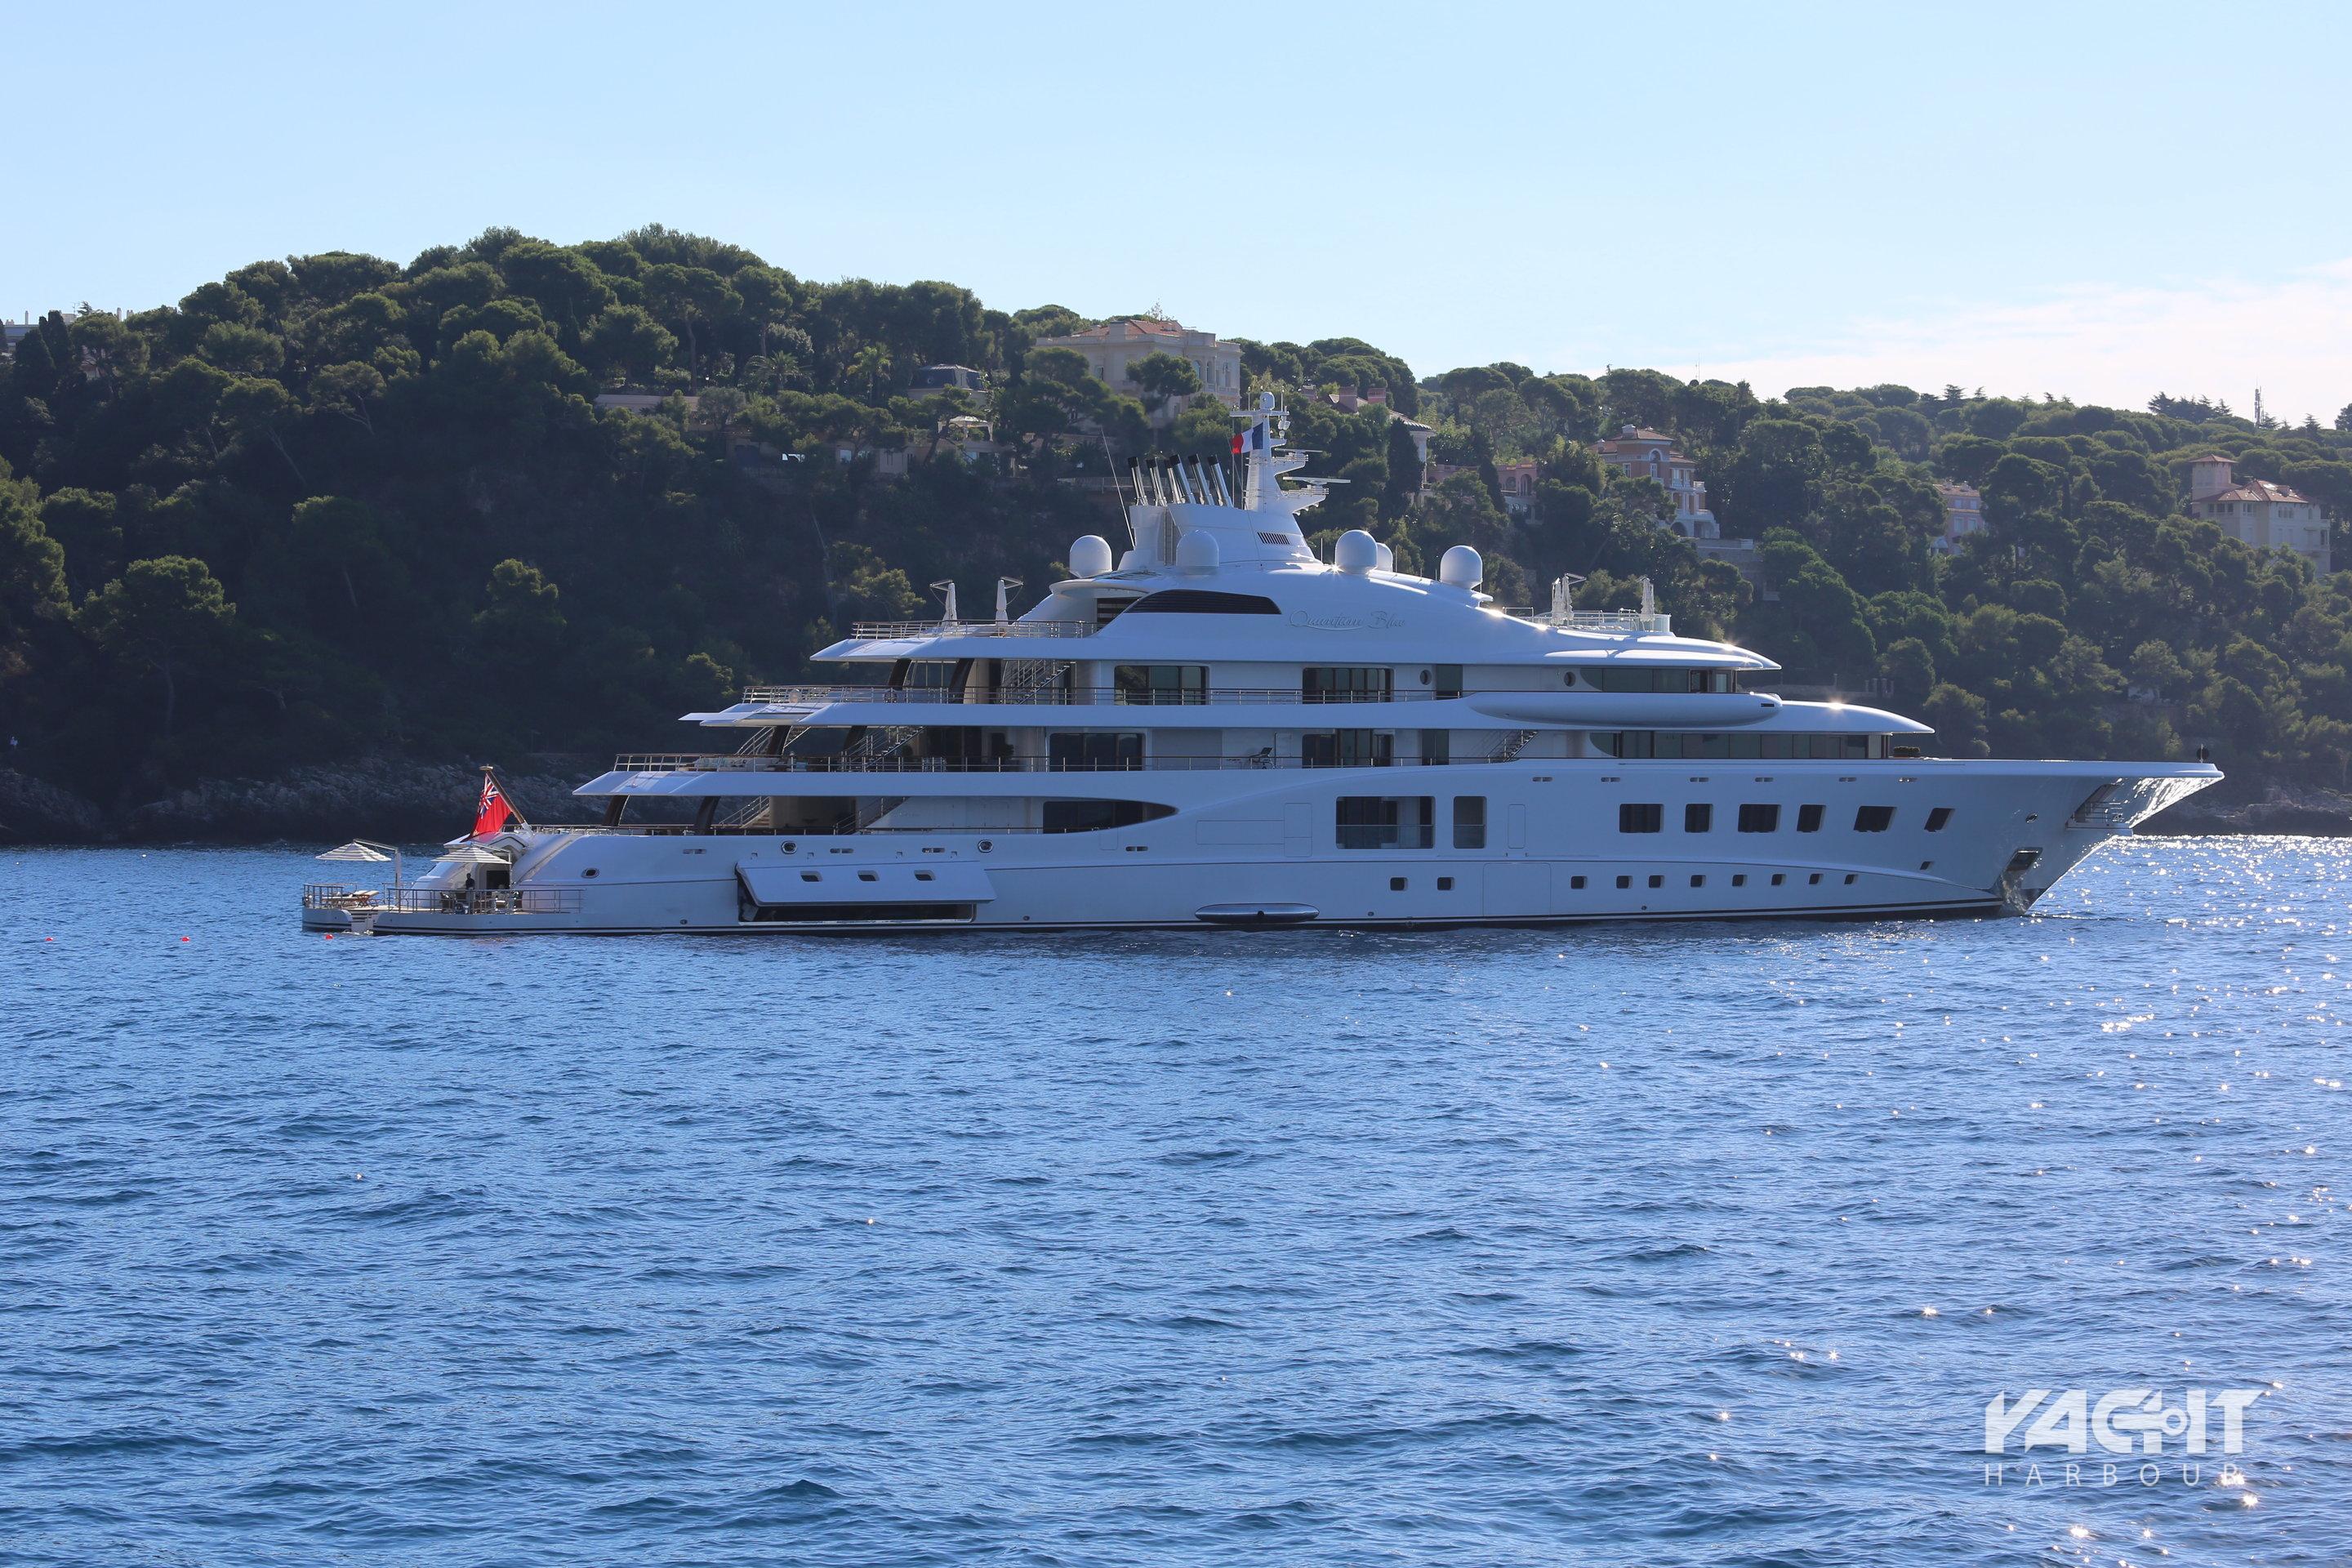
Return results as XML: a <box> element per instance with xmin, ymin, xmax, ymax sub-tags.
<box><xmin>0</xmin><ymin>225</ymin><xmax>2352</xmax><ymax>832</ymax></box>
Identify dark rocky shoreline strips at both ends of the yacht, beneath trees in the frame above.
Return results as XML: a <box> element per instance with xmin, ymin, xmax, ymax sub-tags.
<box><xmin>0</xmin><ymin>757</ymin><xmax>2352</xmax><ymax>844</ymax></box>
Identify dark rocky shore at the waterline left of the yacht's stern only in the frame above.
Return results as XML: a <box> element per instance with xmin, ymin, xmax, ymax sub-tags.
<box><xmin>0</xmin><ymin>757</ymin><xmax>599</xmax><ymax>844</ymax></box>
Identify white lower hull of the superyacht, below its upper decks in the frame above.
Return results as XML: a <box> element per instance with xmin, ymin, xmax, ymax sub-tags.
<box><xmin>304</xmin><ymin>760</ymin><xmax>2218</xmax><ymax>936</ymax></box>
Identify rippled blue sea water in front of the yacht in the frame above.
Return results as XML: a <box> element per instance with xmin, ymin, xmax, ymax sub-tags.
<box><xmin>0</xmin><ymin>840</ymin><xmax>2352</xmax><ymax>1568</ymax></box>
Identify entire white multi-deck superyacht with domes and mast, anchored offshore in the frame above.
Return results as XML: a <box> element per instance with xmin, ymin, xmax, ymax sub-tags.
<box><xmin>304</xmin><ymin>399</ymin><xmax>2221</xmax><ymax>936</ymax></box>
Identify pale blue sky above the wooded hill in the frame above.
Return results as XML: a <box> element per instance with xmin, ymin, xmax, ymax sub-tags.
<box><xmin>18</xmin><ymin>2</ymin><xmax>2352</xmax><ymax>418</ymax></box>
